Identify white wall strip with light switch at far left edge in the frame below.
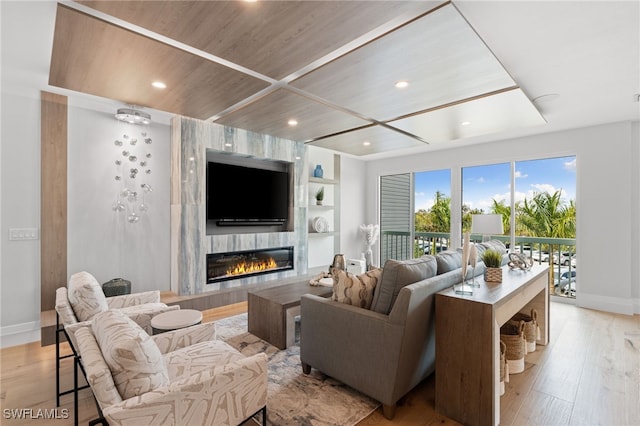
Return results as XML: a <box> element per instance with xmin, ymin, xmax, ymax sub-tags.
<box><xmin>0</xmin><ymin>92</ymin><xmax>40</xmax><ymax>345</ymax></box>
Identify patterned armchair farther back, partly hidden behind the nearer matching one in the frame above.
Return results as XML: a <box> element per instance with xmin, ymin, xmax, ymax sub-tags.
<box><xmin>56</xmin><ymin>272</ymin><xmax>180</xmax><ymax>406</ymax></box>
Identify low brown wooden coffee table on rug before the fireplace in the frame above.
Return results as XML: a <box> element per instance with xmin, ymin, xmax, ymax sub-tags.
<box><xmin>247</xmin><ymin>279</ymin><xmax>333</xmax><ymax>349</ymax></box>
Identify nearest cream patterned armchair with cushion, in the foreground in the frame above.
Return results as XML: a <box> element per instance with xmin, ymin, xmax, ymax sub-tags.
<box><xmin>76</xmin><ymin>311</ymin><xmax>267</xmax><ymax>426</ymax></box>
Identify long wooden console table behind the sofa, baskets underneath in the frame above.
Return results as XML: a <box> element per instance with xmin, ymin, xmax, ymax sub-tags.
<box><xmin>436</xmin><ymin>265</ymin><xmax>549</xmax><ymax>426</ymax></box>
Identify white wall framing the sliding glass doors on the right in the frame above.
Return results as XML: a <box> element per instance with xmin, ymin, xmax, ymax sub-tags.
<box><xmin>366</xmin><ymin>123</ymin><xmax>640</xmax><ymax>314</ymax></box>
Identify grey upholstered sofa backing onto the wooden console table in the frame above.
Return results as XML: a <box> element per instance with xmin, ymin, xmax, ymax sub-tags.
<box><xmin>300</xmin><ymin>241</ymin><xmax>506</xmax><ymax>419</ymax></box>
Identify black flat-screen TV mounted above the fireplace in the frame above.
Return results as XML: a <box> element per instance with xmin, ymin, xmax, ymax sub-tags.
<box><xmin>207</xmin><ymin>161</ymin><xmax>289</xmax><ymax>226</ymax></box>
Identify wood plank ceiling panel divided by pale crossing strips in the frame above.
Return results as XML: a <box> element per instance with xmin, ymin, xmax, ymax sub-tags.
<box><xmin>49</xmin><ymin>0</ymin><xmax>544</xmax><ymax>156</ymax></box>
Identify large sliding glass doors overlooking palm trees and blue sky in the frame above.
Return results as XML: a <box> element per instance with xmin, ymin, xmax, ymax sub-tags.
<box><xmin>380</xmin><ymin>156</ymin><xmax>578</xmax><ymax>297</ymax></box>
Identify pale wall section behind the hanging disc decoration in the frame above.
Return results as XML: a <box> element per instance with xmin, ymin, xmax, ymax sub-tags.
<box><xmin>67</xmin><ymin>105</ymin><xmax>171</xmax><ymax>293</ymax></box>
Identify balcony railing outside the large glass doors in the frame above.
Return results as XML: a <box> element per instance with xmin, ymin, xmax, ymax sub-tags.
<box><xmin>380</xmin><ymin>231</ymin><xmax>577</xmax><ymax>298</ymax></box>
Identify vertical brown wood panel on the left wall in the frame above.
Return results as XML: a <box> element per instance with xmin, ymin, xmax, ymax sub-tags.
<box><xmin>40</xmin><ymin>92</ymin><xmax>67</xmax><ymax>311</ymax></box>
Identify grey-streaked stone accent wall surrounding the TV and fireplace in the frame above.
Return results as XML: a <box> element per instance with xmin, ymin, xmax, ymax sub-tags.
<box><xmin>171</xmin><ymin>117</ymin><xmax>308</xmax><ymax>295</ymax></box>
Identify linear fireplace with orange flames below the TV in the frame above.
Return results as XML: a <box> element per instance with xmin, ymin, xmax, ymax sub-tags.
<box><xmin>207</xmin><ymin>247</ymin><xmax>293</xmax><ymax>284</ymax></box>
